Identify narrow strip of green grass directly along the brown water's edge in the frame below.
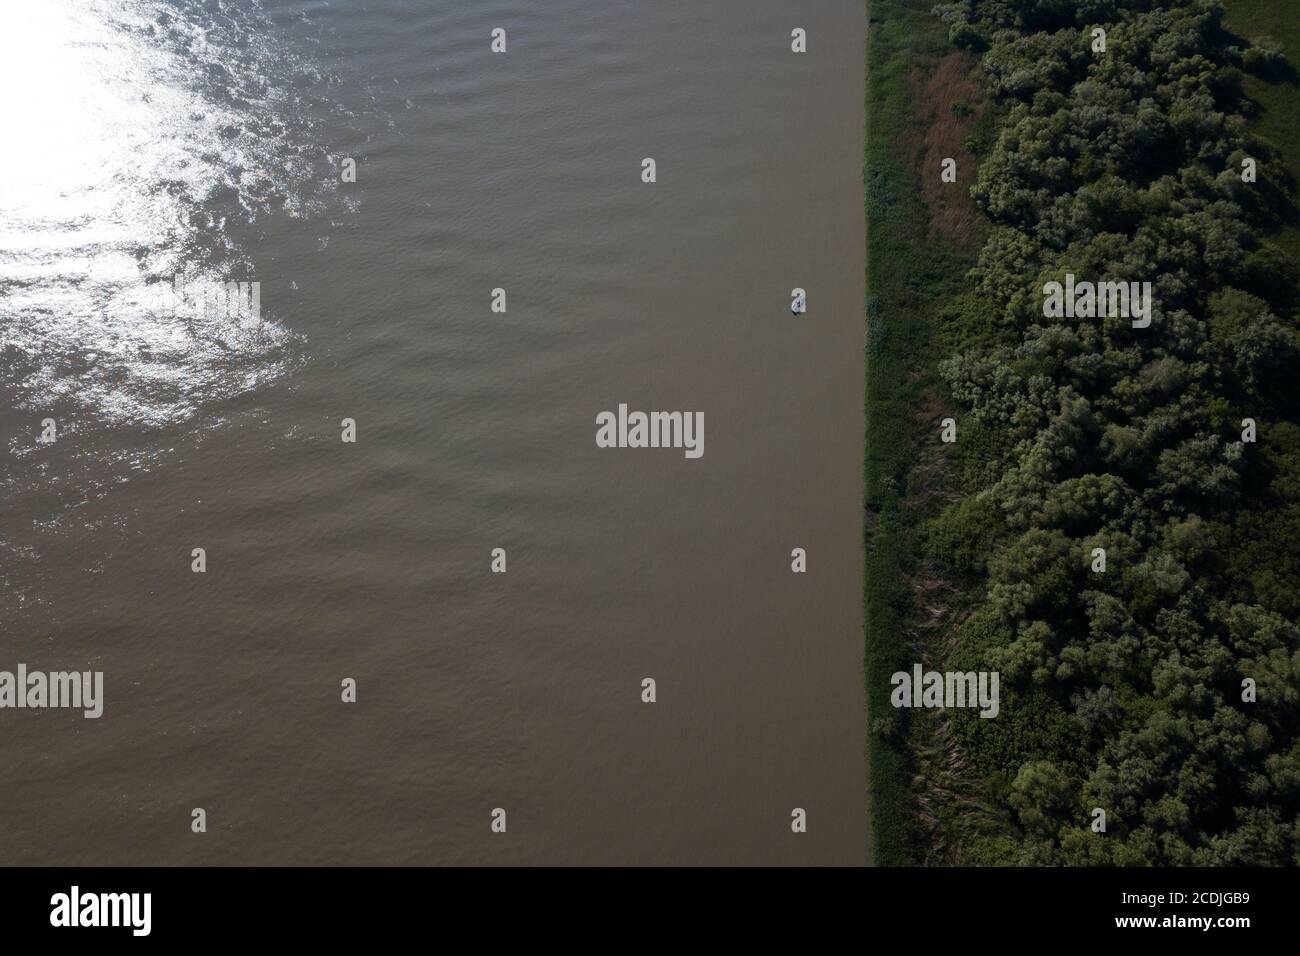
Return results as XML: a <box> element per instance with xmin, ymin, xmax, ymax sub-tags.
<box><xmin>863</xmin><ymin>0</ymin><xmax>978</xmax><ymax>865</ymax></box>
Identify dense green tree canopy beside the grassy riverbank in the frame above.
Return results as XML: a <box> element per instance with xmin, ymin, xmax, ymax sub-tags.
<box><xmin>926</xmin><ymin>0</ymin><xmax>1300</xmax><ymax>865</ymax></box>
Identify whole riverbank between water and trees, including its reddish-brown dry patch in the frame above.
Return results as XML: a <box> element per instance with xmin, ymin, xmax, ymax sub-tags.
<box><xmin>863</xmin><ymin>0</ymin><xmax>984</xmax><ymax>865</ymax></box>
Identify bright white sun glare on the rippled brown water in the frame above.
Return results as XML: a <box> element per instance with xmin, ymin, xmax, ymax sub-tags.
<box><xmin>0</xmin><ymin>0</ymin><xmax>317</xmax><ymax>424</ymax></box>
